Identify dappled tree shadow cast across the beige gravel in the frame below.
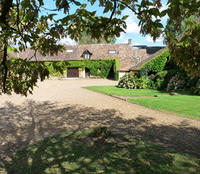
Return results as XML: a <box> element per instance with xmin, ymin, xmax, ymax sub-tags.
<box><xmin>0</xmin><ymin>100</ymin><xmax>200</xmax><ymax>172</ymax></box>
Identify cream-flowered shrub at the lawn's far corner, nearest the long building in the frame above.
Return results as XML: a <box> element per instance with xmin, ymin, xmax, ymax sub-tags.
<box><xmin>117</xmin><ymin>73</ymin><xmax>150</xmax><ymax>89</ymax></box>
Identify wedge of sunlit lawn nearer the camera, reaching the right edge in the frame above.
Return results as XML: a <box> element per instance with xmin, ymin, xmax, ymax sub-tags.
<box><xmin>129</xmin><ymin>95</ymin><xmax>200</xmax><ymax>119</ymax></box>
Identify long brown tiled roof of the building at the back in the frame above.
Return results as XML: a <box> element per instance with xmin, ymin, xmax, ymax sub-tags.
<box><xmin>10</xmin><ymin>44</ymin><xmax>146</xmax><ymax>71</ymax></box>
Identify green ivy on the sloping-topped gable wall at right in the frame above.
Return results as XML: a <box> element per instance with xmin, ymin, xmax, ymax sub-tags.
<box><xmin>139</xmin><ymin>49</ymin><xmax>170</xmax><ymax>76</ymax></box>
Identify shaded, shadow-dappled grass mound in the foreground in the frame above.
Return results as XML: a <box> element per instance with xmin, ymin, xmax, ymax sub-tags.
<box><xmin>0</xmin><ymin>130</ymin><xmax>200</xmax><ymax>174</ymax></box>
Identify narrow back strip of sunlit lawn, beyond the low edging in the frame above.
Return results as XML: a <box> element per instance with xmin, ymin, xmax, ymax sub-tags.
<box><xmin>84</xmin><ymin>86</ymin><xmax>170</xmax><ymax>97</ymax></box>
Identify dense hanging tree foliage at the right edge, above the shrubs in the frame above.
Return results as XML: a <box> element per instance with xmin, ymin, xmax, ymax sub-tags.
<box><xmin>165</xmin><ymin>15</ymin><xmax>200</xmax><ymax>77</ymax></box>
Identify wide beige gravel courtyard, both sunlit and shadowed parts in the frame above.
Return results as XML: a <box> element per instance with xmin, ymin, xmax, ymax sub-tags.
<box><xmin>0</xmin><ymin>79</ymin><xmax>200</xmax><ymax>159</ymax></box>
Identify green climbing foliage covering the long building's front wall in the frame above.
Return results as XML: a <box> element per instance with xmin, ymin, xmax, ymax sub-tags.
<box><xmin>45</xmin><ymin>59</ymin><xmax>120</xmax><ymax>80</ymax></box>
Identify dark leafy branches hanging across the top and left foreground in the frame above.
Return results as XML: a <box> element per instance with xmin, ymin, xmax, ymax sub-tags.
<box><xmin>0</xmin><ymin>0</ymin><xmax>200</xmax><ymax>95</ymax></box>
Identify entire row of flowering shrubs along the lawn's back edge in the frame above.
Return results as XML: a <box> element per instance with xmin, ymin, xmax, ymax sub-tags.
<box><xmin>117</xmin><ymin>71</ymin><xmax>200</xmax><ymax>95</ymax></box>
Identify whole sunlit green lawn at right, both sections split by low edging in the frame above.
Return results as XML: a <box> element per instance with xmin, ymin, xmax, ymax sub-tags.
<box><xmin>85</xmin><ymin>86</ymin><xmax>200</xmax><ymax>119</ymax></box>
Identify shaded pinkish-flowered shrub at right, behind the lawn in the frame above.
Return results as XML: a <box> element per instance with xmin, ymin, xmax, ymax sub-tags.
<box><xmin>167</xmin><ymin>73</ymin><xmax>186</xmax><ymax>91</ymax></box>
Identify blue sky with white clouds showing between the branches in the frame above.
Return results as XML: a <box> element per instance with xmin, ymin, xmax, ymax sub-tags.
<box><xmin>44</xmin><ymin>0</ymin><xmax>167</xmax><ymax>46</ymax></box>
